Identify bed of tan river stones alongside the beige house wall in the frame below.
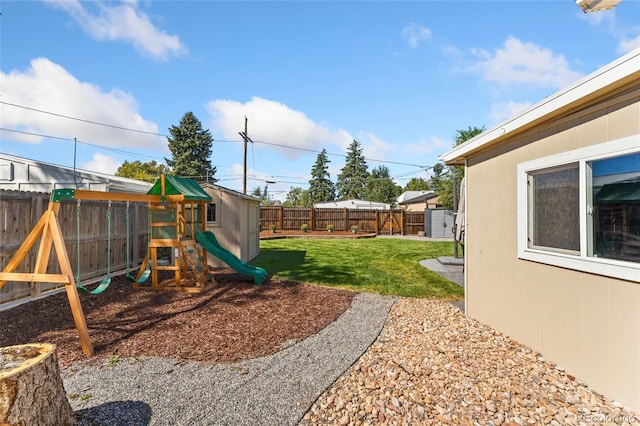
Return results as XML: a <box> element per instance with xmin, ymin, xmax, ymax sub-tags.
<box><xmin>302</xmin><ymin>299</ymin><xmax>640</xmax><ymax>425</ymax></box>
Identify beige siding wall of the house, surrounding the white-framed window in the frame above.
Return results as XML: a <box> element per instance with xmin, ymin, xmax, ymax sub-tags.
<box><xmin>465</xmin><ymin>84</ymin><xmax>640</xmax><ymax>411</ymax></box>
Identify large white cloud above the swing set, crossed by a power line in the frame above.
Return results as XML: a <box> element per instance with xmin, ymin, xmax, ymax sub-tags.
<box><xmin>0</xmin><ymin>58</ymin><xmax>167</xmax><ymax>151</ymax></box>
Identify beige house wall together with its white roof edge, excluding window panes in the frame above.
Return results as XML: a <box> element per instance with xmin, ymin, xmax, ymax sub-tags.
<box><xmin>442</xmin><ymin>49</ymin><xmax>640</xmax><ymax>411</ymax></box>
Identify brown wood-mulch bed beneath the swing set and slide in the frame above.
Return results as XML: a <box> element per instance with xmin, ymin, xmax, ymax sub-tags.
<box><xmin>0</xmin><ymin>268</ymin><xmax>355</xmax><ymax>368</ymax></box>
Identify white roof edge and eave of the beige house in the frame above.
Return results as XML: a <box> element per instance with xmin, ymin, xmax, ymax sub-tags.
<box><xmin>440</xmin><ymin>48</ymin><xmax>640</xmax><ymax>164</ymax></box>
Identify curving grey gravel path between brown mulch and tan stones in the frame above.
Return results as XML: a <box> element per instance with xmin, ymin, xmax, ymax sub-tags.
<box><xmin>62</xmin><ymin>294</ymin><xmax>396</xmax><ymax>426</ymax></box>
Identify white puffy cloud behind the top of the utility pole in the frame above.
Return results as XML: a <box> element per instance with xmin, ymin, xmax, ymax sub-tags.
<box><xmin>206</xmin><ymin>97</ymin><xmax>353</xmax><ymax>159</ymax></box>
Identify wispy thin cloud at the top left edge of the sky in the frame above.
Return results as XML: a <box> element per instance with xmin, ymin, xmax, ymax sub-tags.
<box><xmin>44</xmin><ymin>0</ymin><xmax>187</xmax><ymax>60</ymax></box>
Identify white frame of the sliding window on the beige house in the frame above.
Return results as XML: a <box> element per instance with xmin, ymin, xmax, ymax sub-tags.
<box><xmin>517</xmin><ymin>134</ymin><xmax>640</xmax><ymax>282</ymax></box>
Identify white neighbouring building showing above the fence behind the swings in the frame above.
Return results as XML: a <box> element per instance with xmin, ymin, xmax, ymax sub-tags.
<box><xmin>0</xmin><ymin>153</ymin><xmax>151</xmax><ymax>194</ymax></box>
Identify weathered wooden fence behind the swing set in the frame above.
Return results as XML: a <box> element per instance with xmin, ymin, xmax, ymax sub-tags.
<box><xmin>0</xmin><ymin>190</ymin><xmax>149</xmax><ymax>305</ymax></box>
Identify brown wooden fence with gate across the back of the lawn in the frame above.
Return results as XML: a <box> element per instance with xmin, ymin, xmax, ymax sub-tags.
<box><xmin>260</xmin><ymin>206</ymin><xmax>424</xmax><ymax>235</ymax></box>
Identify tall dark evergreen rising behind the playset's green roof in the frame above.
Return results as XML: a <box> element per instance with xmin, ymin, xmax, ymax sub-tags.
<box><xmin>165</xmin><ymin>112</ymin><xmax>216</xmax><ymax>182</ymax></box>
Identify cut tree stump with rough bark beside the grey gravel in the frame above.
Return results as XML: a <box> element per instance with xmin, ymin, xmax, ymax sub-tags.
<box><xmin>0</xmin><ymin>343</ymin><xmax>76</xmax><ymax>426</ymax></box>
